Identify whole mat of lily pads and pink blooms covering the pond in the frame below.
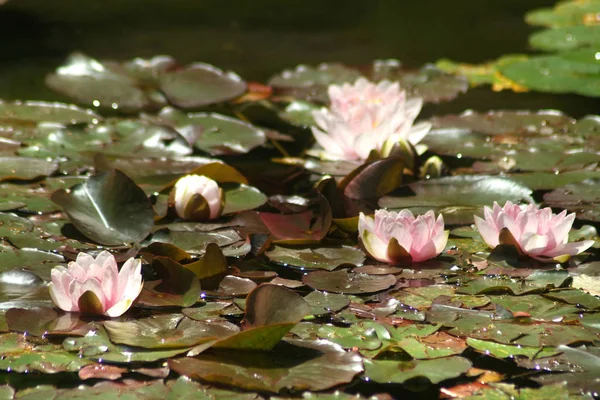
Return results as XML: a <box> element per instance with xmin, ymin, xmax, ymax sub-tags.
<box><xmin>0</xmin><ymin>1</ymin><xmax>600</xmax><ymax>399</ymax></box>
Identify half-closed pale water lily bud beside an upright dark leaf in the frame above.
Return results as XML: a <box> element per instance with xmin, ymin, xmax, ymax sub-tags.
<box><xmin>172</xmin><ymin>175</ymin><xmax>223</xmax><ymax>221</ymax></box>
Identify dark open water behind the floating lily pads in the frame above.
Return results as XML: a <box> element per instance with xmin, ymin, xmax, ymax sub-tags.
<box><xmin>0</xmin><ymin>0</ymin><xmax>599</xmax><ymax>116</ymax></box>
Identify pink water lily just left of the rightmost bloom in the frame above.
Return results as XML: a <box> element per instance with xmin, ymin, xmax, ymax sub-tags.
<box><xmin>358</xmin><ymin>210</ymin><xmax>448</xmax><ymax>264</ymax></box>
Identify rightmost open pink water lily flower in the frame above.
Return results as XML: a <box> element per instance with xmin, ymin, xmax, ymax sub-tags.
<box><xmin>475</xmin><ymin>201</ymin><xmax>594</xmax><ymax>262</ymax></box>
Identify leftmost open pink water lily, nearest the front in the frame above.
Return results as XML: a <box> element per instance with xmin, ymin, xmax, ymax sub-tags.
<box><xmin>49</xmin><ymin>251</ymin><xmax>143</xmax><ymax>317</ymax></box>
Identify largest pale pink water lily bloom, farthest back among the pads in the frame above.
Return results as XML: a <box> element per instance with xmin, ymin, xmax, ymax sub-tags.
<box><xmin>312</xmin><ymin>78</ymin><xmax>431</xmax><ymax>160</ymax></box>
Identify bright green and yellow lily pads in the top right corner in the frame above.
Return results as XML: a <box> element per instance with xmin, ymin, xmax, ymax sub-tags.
<box><xmin>437</xmin><ymin>0</ymin><xmax>600</xmax><ymax>97</ymax></box>
